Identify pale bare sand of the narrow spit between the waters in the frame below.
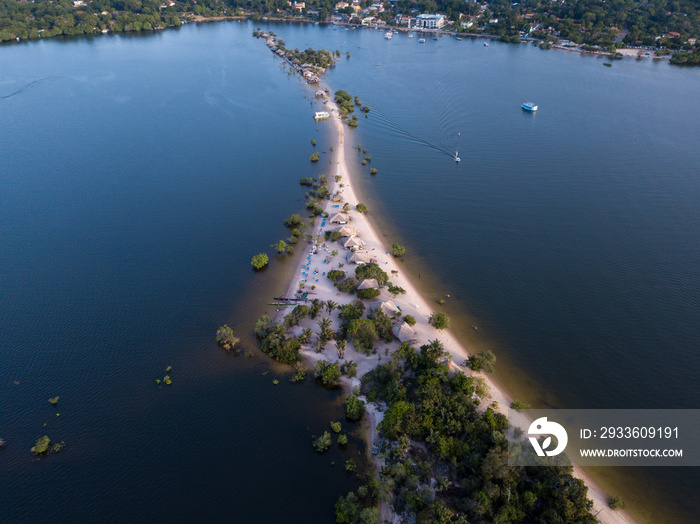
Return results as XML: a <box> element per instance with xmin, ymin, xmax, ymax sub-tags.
<box><xmin>277</xmin><ymin>88</ymin><xmax>634</xmax><ymax>524</ymax></box>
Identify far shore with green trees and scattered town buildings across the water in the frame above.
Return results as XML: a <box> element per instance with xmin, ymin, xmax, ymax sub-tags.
<box><xmin>0</xmin><ymin>0</ymin><xmax>700</xmax><ymax>65</ymax></box>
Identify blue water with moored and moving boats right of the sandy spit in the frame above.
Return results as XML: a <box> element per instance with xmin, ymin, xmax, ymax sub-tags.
<box><xmin>258</xmin><ymin>27</ymin><xmax>700</xmax><ymax>522</ymax></box>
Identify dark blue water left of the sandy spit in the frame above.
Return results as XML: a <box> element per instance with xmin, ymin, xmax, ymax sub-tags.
<box><xmin>0</xmin><ymin>24</ymin><xmax>363</xmax><ymax>522</ymax></box>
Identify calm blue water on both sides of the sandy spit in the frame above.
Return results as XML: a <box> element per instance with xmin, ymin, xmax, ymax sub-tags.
<box><xmin>0</xmin><ymin>23</ymin><xmax>700</xmax><ymax>522</ymax></box>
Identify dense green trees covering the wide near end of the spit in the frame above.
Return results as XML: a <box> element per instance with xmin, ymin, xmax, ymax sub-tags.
<box><xmin>336</xmin><ymin>341</ymin><xmax>597</xmax><ymax>524</ymax></box>
